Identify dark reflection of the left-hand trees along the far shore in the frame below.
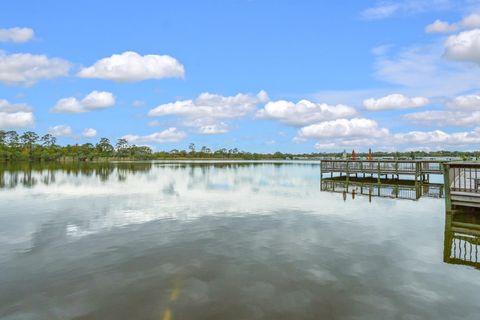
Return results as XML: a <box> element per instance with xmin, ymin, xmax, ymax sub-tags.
<box><xmin>0</xmin><ymin>162</ymin><xmax>152</xmax><ymax>189</ymax></box>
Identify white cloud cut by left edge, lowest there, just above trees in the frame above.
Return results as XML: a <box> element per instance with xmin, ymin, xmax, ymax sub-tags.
<box><xmin>0</xmin><ymin>99</ymin><xmax>35</xmax><ymax>129</ymax></box>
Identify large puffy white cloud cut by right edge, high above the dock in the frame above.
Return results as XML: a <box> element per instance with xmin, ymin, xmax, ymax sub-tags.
<box><xmin>445</xmin><ymin>29</ymin><xmax>480</xmax><ymax>64</ymax></box>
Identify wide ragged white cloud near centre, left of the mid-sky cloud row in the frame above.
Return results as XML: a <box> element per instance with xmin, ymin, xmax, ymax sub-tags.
<box><xmin>148</xmin><ymin>91</ymin><xmax>268</xmax><ymax>134</ymax></box>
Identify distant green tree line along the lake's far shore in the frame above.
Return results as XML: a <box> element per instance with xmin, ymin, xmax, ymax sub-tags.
<box><xmin>0</xmin><ymin>130</ymin><xmax>480</xmax><ymax>162</ymax></box>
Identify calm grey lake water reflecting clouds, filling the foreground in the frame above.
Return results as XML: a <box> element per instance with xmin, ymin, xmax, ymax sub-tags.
<box><xmin>0</xmin><ymin>162</ymin><xmax>480</xmax><ymax>320</ymax></box>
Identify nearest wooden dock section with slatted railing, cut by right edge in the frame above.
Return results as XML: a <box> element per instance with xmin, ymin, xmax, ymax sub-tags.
<box><xmin>443</xmin><ymin>162</ymin><xmax>480</xmax><ymax>211</ymax></box>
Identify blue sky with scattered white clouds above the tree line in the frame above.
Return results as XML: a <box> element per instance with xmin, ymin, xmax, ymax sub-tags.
<box><xmin>0</xmin><ymin>0</ymin><xmax>480</xmax><ymax>152</ymax></box>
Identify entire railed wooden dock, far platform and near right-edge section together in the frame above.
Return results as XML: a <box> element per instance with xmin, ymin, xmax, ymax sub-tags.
<box><xmin>320</xmin><ymin>159</ymin><xmax>480</xmax><ymax>211</ymax></box>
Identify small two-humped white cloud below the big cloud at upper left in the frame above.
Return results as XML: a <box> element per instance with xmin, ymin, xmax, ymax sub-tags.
<box><xmin>50</xmin><ymin>90</ymin><xmax>115</xmax><ymax>113</ymax></box>
